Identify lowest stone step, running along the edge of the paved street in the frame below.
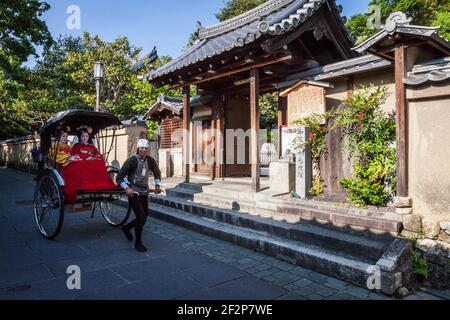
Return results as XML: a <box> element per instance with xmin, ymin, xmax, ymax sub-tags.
<box><xmin>150</xmin><ymin>204</ymin><xmax>371</xmax><ymax>287</ymax></box>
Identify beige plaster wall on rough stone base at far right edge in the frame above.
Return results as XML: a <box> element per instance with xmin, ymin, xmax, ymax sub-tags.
<box><xmin>402</xmin><ymin>82</ymin><xmax>450</xmax><ymax>289</ymax></box>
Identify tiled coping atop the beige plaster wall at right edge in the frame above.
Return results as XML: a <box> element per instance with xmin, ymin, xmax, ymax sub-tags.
<box><xmin>403</xmin><ymin>57</ymin><xmax>450</xmax><ymax>86</ymax></box>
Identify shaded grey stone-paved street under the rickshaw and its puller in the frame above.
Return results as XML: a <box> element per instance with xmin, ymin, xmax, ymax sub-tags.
<box><xmin>0</xmin><ymin>169</ymin><xmax>438</xmax><ymax>300</ymax></box>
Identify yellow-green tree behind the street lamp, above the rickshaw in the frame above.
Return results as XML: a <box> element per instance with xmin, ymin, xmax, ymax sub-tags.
<box><xmin>24</xmin><ymin>33</ymin><xmax>178</xmax><ymax>119</ymax></box>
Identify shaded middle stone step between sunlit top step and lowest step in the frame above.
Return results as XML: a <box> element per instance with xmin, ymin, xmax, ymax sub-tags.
<box><xmin>151</xmin><ymin>196</ymin><xmax>393</xmax><ymax>263</ymax></box>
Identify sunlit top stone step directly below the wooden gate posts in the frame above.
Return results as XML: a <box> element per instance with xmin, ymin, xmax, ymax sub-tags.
<box><xmin>166</xmin><ymin>184</ymin><xmax>402</xmax><ymax>237</ymax></box>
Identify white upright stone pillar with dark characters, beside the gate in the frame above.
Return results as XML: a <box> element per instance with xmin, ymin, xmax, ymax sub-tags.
<box><xmin>295</xmin><ymin>127</ymin><xmax>312</xmax><ymax>198</ymax></box>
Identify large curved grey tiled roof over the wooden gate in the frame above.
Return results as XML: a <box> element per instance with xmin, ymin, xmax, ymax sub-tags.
<box><xmin>147</xmin><ymin>0</ymin><xmax>348</xmax><ymax>81</ymax></box>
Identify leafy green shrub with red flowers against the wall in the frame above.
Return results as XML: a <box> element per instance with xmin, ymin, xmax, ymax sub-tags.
<box><xmin>335</xmin><ymin>86</ymin><xmax>396</xmax><ymax>206</ymax></box>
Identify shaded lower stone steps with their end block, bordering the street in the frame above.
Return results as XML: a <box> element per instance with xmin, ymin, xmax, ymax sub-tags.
<box><xmin>146</xmin><ymin>200</ymin><xmax>412</xmax><ymax>295</ymax></box>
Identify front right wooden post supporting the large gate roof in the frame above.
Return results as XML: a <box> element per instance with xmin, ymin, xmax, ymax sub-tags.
<box><xmin>250</xmin><ymin>69</ymin><xmax>261</xmax><ymax>192</ymax></box>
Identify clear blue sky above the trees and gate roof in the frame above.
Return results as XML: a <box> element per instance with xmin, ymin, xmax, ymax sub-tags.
<box><xmin>31</xmin><ymin>0</ymin><xmax>369</xmax><ymax>65</ymax></box>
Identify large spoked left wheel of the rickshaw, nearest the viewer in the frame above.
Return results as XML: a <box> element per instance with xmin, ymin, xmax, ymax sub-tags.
<box><xmin>33</xmin><ymin>172</ymin><xmax>64</xmax><ymax>240</ymax></box>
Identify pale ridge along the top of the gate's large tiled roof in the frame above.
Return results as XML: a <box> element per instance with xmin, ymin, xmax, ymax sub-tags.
<box><xmin>199</xmin><ymin>0</ymin><xmax>295</xmax><ymax>40</ymax></box>
